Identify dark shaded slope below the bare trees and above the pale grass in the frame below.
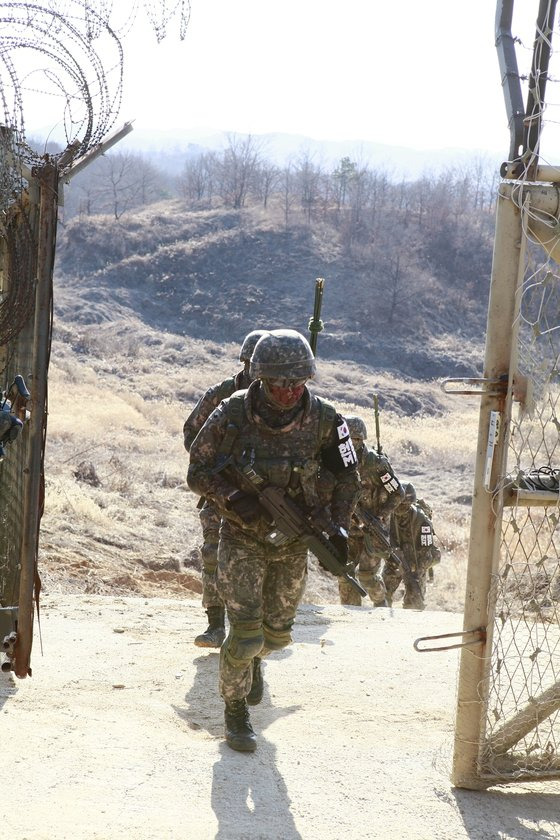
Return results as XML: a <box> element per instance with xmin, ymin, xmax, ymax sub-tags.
<box><xmin>57</xmin><ymin>200</ymin><xmax>486</xmax><ymax>390</ymax></box>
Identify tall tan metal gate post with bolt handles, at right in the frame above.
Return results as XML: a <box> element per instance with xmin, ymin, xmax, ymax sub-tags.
<box><xmin>452</xmin><ymin>185</ymin><xmax>526</xmax><ymax>789</ymax></box>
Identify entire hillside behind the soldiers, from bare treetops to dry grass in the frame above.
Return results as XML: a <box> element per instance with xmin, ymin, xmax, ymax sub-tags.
<box><xmin>41</xmin><ymin>151</ymin><xmax>498</xmax><ymax>610</ymax></box>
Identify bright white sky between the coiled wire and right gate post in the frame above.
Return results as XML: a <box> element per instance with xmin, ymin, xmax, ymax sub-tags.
<box><xmin>24</xmin><ymin>0</ymin><xmax>560</xmax><ymax>163</ymax></box>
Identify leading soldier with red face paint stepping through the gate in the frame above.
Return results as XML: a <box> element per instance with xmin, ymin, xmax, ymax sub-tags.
<box><xmin>187</xmin><ymin>329</ymin><xmax>359</xmax><ymax>751</ymax></box>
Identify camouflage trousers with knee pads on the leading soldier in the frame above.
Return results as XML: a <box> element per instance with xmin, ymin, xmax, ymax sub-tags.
<box><xmin>217</xmin><ymin>534</ymin><xmax>307</xmax><ymax>702</ymax></box>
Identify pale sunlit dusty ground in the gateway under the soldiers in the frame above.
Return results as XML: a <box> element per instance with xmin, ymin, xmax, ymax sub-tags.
<box><xmin>0</xmin><ymin>594</ymin><xmax>560</xmax><ymax>840</ymax></box>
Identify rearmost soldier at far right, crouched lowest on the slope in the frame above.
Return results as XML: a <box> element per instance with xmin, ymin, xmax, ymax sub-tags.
<box><xmin>383</xmin><ymin>483</ymin><xmax>441</xmax><ymax>610</ymax></box>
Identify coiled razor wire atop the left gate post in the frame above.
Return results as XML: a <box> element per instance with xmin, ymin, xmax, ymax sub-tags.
<box><xmin>0</xmin><ymin>0</ymin><xmax>190</xmax><ymax>165</ymax></box>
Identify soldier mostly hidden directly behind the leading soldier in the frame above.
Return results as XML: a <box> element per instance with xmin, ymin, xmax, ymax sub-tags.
<box><xmin>183</xmin><ymin>330</ymin><xmax>268</xmax><ymax>647</ymax></box>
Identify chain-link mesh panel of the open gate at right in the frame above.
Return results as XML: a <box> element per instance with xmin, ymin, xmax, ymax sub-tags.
<box><xmin>480</xmin><ymin>247</ymin><xmax>560</xmax><ymax>781</ymax></box>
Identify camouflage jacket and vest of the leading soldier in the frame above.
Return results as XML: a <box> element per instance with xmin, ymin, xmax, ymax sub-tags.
<box><xmin>187</xmin><ymin>381</ymin><xmax>359</xmax><ymax>540</ymax></box>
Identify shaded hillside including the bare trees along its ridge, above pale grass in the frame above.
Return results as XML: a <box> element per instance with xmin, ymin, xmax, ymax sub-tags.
<box><xmin>58</xmin><ymin>138</ymin><xmax>493</xmax><ymax>379</ymax></box>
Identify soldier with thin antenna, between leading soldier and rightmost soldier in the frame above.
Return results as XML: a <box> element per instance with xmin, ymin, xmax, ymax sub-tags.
<box><xmin>338</xmin><ymin>415</ymin><xmax>404</xmax><ymax>607</ymax></box>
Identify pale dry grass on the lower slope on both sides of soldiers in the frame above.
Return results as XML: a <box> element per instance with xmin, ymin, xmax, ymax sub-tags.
<box><xmin>40</xmin><ymin>321</ymin><xmax>477</xmax><ymax>610</ymax></box>
